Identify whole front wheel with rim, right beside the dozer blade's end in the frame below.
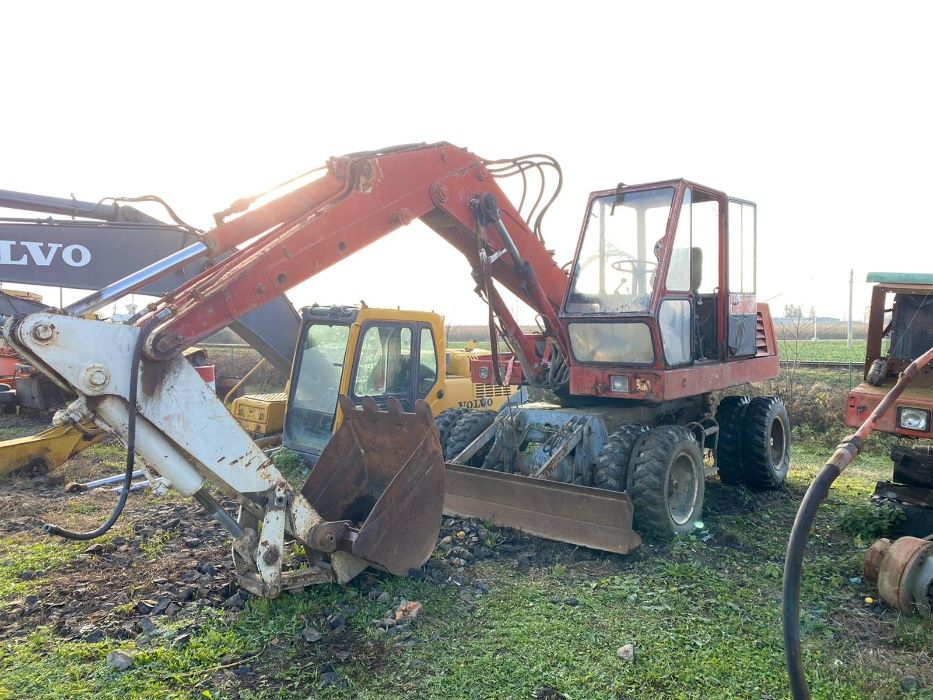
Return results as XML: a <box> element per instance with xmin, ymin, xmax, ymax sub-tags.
<box><xmin>630</xmin><ymin>425</ymin><xmax>705</xmax><ymax>539</ymax></box>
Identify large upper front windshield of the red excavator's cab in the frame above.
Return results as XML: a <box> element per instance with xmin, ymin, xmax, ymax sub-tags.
<box><xmin>566</xmin><ymin>187</ymin><xmax>674</xmax><ymax>314</ymax></box>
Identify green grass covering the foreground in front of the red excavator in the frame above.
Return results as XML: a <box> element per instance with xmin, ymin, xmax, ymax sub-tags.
<box><xmin>0</xmin><ymin>440</ymin><xmax>933</xmax><ymax>700</ymax></box>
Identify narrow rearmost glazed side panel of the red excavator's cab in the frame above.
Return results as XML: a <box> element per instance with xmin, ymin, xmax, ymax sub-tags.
<box><xmin>726</xmin><ymin>198</ymin><xmax>758</xmax><ymax>357</ymax></box>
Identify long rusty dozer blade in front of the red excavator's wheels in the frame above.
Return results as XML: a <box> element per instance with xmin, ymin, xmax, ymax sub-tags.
<box><xmin>444</xmin><ymin>464</ymin><xmax>641</xmax><ymax>554</ymax></box>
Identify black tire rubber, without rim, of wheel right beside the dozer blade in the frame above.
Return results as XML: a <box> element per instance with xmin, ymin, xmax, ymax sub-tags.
<box><xmin>630</xmin><ymin>425</ymin><xmax>705</xmax><ymax>540</ymax></box>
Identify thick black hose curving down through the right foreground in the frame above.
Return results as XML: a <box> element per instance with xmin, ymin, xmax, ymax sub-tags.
<box><xmin>782</xmin><ymin>348</ymin><xmax>933</xmax><ymax>700</ymax></box>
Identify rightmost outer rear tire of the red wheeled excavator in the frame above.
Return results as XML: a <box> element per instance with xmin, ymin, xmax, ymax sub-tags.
<box><xmin>742</xmin><ymin>396</ymin><xmax>791</xmax><ymax>490</ymax></box>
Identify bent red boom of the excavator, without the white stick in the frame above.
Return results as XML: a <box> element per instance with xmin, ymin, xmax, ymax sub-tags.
<box><xmin>63</xmin><ymin>143</ymin><xmax>570</xmax><ymax>388</ymax></box>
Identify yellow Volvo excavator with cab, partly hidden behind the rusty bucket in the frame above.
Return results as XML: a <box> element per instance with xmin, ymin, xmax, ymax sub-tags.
<box><xmin>228</xmin><ymin>304</ymin><xmax>526</xmax><ymax>452</ymax></box>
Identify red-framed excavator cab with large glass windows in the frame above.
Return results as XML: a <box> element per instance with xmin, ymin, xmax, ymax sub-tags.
<box><xmin>562</xmin><ymin>180</ymin><xmax>759</xmax><ymax>400</ymax></box>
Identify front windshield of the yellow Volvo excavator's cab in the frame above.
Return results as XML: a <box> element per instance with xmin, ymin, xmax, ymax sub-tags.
<box><xmin>285</xmin><ymin>324</ymin><xmax>350</xmax><ymax>451</ymax></box>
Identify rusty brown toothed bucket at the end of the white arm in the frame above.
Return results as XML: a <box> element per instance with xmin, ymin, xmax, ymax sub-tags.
<box><xmin>301</xmin><ymin>396</ymin><xmax>444</xmax><ymax>575</ymax></box>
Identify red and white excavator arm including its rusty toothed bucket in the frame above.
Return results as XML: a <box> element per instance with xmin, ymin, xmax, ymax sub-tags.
<box><xmin>3</xmin><ymin>143</ymin><xmax>570</xmax><ymax>596</ymax></box>
